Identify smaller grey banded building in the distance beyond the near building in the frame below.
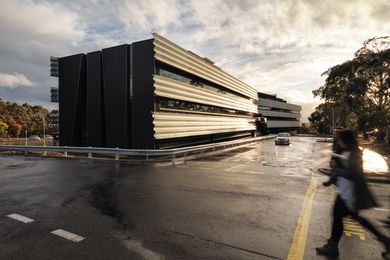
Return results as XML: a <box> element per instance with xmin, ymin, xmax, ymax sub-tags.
<box><xmin>258</xmin><ymin>92</ymin><xmax>302</xmax><ymax>133</ymax></box>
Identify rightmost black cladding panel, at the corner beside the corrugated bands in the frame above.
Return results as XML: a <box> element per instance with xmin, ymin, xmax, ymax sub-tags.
<box><xmin>131</xmin><ymin>40</ymin><xmax>156</xmax><ymax>149</ymax></box>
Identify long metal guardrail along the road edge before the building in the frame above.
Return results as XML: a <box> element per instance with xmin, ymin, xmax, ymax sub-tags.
<box><xmin>0</xmin><ymin>135</ymin><xmax>275</xmax><ymax>161</ymax></box>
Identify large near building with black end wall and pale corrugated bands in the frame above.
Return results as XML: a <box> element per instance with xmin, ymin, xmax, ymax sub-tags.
<box><xmin>56</xmin><ymin>34</ymin><xmax>258</xmax><ymax>149</ymax></box>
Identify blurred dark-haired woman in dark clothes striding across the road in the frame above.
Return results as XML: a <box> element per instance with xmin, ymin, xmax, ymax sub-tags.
<box><xmin>316</xmin><ymin>130</ymin><xmax>390</xmax><ymax>259</ymax></box>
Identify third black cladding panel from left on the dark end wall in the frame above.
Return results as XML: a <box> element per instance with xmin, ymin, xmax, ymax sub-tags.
<box><xmin>102</xmin><ymin>45</ymin><xmax>130</xmax><ymax>148</ymax></box>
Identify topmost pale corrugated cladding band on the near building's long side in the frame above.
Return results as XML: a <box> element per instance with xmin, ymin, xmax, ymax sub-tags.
<box><xmin>153</xmin><ymin>33</ymin><xmax>258</xmax><ymax>100</ymax></box>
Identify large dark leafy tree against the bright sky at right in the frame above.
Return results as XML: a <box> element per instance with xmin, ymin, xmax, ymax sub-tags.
<box><xmin>309</xmin><ymin>36</ymin><xmax>390</xmax><ymax>141</ymax></box>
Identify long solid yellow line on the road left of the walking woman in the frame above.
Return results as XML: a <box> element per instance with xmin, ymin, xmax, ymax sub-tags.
<box><xmin>287</xmin><ymin>179</ymin><xmax>317</xmax><ymax>260</ymax></box>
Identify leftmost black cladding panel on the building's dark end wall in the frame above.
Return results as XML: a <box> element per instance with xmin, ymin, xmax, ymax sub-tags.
<box><xmin>58</xmin><ymin>54</ymin><xmax>86</xmax><ymax>146</ymax></box>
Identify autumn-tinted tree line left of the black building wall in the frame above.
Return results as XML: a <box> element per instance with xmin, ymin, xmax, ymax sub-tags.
<box><xmin>0</xmin><ymin>98</ymin><xmax>58</xmax><ymax>138</ymax></box>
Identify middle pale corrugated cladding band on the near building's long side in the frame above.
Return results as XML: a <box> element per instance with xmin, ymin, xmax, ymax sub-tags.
<box><xmin>154</xmin><ymin>75</ymin><xmax>257</xmax><ymax>113</ymax></box>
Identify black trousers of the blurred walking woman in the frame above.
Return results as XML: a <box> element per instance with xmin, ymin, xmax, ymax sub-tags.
<box><xmin>330</xmin><ymin>196</ymin><xmax>385</xmax><ymax>243</ymax></box>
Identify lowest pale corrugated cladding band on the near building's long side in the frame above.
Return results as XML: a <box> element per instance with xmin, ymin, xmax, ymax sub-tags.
<box><xmin>153</xmin><ymin>112</ymin><xmax>256</xmax><ymax>139</ymax></box>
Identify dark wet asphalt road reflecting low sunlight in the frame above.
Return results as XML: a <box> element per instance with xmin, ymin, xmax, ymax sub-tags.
<box><xmin>0</xmin><ymin>137</ymin><xmax>390</xmax><ymax>259</ymax></box>
